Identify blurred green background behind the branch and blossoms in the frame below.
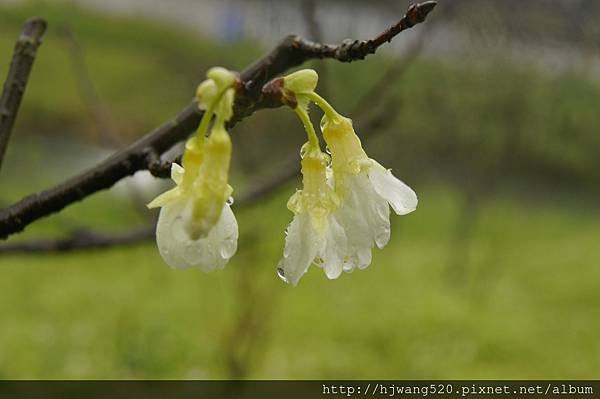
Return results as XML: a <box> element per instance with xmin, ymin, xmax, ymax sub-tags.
<box><xmin>0</xmin><ymin>0</ymin><xmax>600</xmax><ymax>379</ymax></box>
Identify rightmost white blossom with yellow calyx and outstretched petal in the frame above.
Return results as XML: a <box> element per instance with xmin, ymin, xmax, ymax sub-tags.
<box><xmin>321</xmin><ymin>116</ymin><xmax>418</xmax><ymax>271</ymax></box>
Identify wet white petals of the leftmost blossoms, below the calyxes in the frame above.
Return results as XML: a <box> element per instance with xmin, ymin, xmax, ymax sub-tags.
<box><xmin>152</xmin><ymin>163</ymin><xmax>238</xmax><ymax>272</ymax></box>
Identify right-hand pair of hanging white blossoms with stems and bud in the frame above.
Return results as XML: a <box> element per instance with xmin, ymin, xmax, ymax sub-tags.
<box><xmin>276</xmin><ymin>69</ymin><xmax>417</xmax><ymax>285</ymax></box>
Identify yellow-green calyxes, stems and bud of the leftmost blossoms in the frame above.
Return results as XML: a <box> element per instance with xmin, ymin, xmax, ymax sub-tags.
<box><xmin>148</xmin><ymin>67</ymin><xmax>236</xmax><ymax>240</ymax></box>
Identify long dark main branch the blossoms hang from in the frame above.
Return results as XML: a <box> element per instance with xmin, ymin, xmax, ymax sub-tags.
<box><xmin>0</xmin><ymin>1</ymin><xmax>436</xmax><ymax>239</ymax></box>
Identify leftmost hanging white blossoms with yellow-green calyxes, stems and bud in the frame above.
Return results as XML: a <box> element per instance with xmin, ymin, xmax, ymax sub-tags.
<box><xmin>148</xmin><ymin>68</ymin><xmax>238</xmax><ymax>271</ymax></box>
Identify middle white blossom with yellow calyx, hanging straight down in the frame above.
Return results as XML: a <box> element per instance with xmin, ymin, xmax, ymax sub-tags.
<box><xmin>278</xmin><ymin>148</ymin><xmax>348</xmax><ymax>285</ymax></box>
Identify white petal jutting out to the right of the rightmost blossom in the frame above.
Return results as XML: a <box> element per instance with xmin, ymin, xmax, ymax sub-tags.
<box><xmin>369</xmin><ymin>164</ymin><xmax>418</xmax><ymax>215</ymax></box>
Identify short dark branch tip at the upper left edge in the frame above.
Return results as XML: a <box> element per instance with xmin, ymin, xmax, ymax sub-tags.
<box><xmin>0</xmin><ymin>17</ymin><xmax>46</xmax><ymax>172</ymax></box>
